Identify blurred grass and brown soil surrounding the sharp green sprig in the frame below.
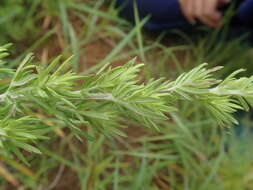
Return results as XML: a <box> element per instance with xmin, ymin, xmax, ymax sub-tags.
<box><xmin>0</xmin><ymin>0</ymin><xmax>253</xmax><ymax>190</ymax></box>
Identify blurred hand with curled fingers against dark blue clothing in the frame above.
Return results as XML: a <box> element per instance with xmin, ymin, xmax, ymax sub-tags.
<box><xmin>179</xmin><ymin>0</ymin><xmax>229</xmax><ymax>28</ymax></box>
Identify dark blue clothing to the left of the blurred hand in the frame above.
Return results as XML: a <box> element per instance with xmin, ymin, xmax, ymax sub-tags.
<box><xmin>117</xmin><ymin>0</ymin><xmax>191</xmax><ymax>30</ymax></box>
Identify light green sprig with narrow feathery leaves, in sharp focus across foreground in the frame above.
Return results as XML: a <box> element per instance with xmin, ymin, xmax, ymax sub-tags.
<box><xmin>0</xmin><ymin>45</ymin><xmax>253</xmax><ymax>161</ymax></box>
